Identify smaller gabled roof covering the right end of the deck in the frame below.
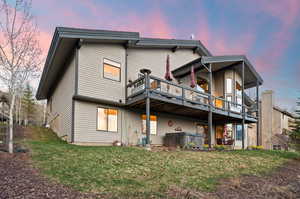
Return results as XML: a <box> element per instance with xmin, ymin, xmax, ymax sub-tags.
<box><xmin>172</xmin><ymin>55</ymin><xmax>263</xmax><ymax>89</ymax></box>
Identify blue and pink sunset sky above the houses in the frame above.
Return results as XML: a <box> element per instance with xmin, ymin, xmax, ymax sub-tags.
<box><xmin>27</xmin><ymin>0</ymin><xmax>300</xmax><ymax>110</ymax></box>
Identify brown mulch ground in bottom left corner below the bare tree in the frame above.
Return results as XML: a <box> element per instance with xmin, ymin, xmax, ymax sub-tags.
<box><xmin>0</xmin><ymin>152</ymin><xmax>102</xmax><ymax>199</ymax></box>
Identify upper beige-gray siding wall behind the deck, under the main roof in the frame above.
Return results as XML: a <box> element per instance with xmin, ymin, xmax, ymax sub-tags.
<box><xmin>128</xmin><ymin>48</ymin><xmax>200</xmax><ymax>80</ymax></box>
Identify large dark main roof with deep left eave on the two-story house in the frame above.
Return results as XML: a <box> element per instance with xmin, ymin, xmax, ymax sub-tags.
<box><xmin>36</xmin><ymin>27</ymin><xmax>211</xmax><ymax>100</ymax></box>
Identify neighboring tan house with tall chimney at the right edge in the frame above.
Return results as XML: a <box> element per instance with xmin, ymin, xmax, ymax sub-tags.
<box><xmin>259</xmin><ymin>90</ymin><xmax>296</xmax><ymax>150</ymax></box>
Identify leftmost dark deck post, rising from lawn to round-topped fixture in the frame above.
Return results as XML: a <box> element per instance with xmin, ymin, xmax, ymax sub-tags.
<box><xmin>140</xmin><ymin>69</ymin><xmax>151</xmax><ymax>147</ymax></box>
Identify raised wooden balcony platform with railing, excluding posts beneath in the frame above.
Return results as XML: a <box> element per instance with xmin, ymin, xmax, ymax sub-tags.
<box><xmin>126</xmin><ymin>75</ymin><xmax>257</xmax><ymax>123</ymax></box>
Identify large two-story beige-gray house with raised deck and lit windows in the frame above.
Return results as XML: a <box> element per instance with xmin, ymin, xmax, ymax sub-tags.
<box><xmin>36</xmin><ymin>27</ymin><xmax>263</xmax><ymax>148</ymax></box>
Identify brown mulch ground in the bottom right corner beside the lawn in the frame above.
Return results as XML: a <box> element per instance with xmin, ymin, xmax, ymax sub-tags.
<box><xmin>168</xmin><ymin>160</ymin><xmax>300</xmax><ymax>199</ymax></box>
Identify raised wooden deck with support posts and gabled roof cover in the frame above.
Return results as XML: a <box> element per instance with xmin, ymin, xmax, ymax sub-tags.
<box><xmin>126</xmin><ymin>56</ymin><xmax>262</xmax><ymax>148</ymax></box>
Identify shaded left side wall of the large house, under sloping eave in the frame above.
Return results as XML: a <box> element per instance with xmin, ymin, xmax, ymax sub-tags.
<box><xmin>47</xmin><ymin>52</ymin><xmax>75</xmax><ymax>142</ymax></box>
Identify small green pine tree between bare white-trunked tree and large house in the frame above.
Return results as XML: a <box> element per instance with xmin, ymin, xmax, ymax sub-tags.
<box><xmin>22</xmin><ymin>83</ymin><xmax>35</xmax><ymax>126</ymax></box>
